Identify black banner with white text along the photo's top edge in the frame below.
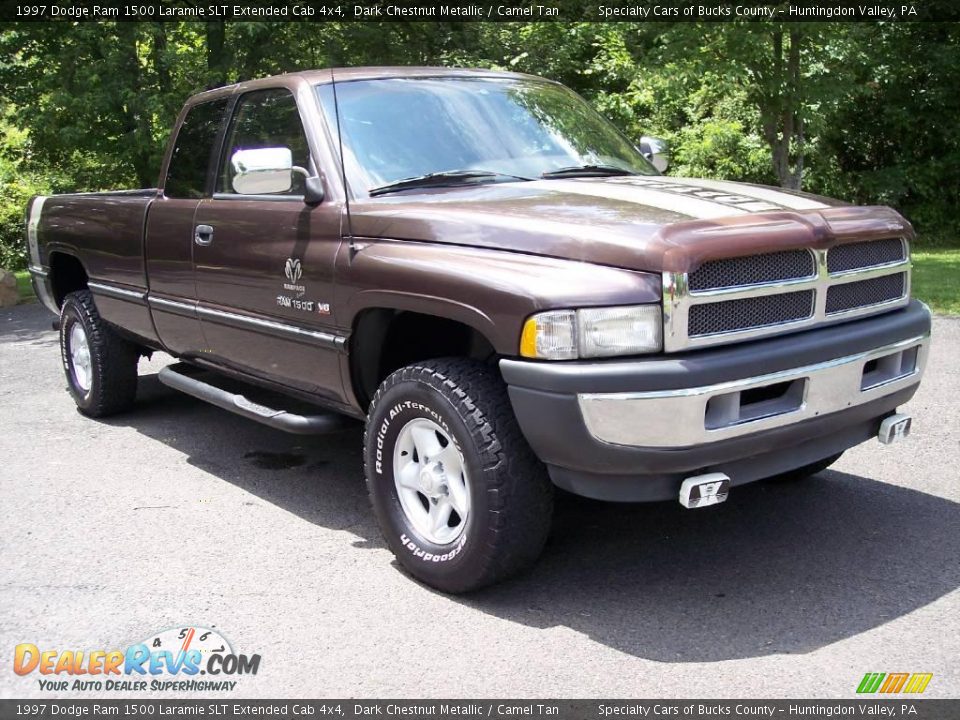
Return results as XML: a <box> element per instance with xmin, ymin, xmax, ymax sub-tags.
<box><xmin>0</xmin><ymin>0</ymin><xmax>960</xmax><ymax>23</ymax></box>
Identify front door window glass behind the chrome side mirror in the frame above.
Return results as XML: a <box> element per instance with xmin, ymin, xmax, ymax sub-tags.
<box><xmin>216</xmin><ymin>89</ymin><xmax>312</xmax><ymax>195</ymax></box>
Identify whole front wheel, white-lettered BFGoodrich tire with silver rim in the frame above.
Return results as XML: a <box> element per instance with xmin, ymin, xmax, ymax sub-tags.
<box><xmin>364</xmin><ymin>358</ymin><xmax>553</xmax><ymax>592</ymax></box>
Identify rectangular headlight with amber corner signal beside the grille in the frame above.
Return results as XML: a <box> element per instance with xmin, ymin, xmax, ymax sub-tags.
<box><xmin>520</xmin><ymin>305</ymin><xmax>663</xmax><ymax>360</ymax></box>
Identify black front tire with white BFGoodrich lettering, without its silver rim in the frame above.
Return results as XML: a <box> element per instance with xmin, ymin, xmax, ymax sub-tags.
<box><xmin>364</xmin><ymin>358</ymin><xmax>553</xmax><ymax>593</ymax></box>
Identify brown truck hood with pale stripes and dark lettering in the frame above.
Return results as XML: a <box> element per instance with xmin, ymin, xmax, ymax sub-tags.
<box><xmin>350</xmin><ymin>176</ymin><xmax>913</xmax><ymax>272</ymax></box>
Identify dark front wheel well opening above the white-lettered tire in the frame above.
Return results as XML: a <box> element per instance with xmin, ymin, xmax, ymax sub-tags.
<box><xmin>350</xmin><ymin>308</ymin><xmax>496</xmax><ymax>408</ymax></box>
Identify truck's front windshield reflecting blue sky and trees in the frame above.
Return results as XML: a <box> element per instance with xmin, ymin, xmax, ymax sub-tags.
<box><xmin>318</xmin><ymin>78</ymin><xmax>657</xmax><ymax>192</ymax></box>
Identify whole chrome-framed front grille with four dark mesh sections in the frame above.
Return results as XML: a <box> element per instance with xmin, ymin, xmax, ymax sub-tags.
<box><xmin>663</xmin><ymin>238</ymin><xmax>910</xmax><ymax>352</ymax></box>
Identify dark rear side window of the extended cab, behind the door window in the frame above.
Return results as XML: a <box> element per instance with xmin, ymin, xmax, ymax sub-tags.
<box><xmin>163</xmin><ymin>98</ymin><xmax>229</xmax><ymax>199</ymax></box>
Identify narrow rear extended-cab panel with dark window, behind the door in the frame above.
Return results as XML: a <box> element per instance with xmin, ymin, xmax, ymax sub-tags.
<box><xmin>145</xmin><ymin>97</ymin><xmax>230</xmax><ymax>357</ymax></box>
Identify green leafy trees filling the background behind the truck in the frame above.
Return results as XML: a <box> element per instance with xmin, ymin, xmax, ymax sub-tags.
<box><xmin>0</xmin><ymin>21</ymin><xmax>960</xmax><ymax>267</ymax></box>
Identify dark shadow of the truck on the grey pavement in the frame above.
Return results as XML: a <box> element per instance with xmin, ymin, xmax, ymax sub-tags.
<box><xmin>109</xmin><ymin>376</ymin><xmax>960</xmax><ymax>662</ymax></box>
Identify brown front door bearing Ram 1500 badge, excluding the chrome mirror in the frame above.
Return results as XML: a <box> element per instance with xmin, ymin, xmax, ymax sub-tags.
<box><xmin>194</xmin><ymin>88</ymin><xmax>342</xmax><ymax>399</ymax></box>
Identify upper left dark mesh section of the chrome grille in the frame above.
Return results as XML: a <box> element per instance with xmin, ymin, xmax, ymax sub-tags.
<box><xmin>687</xmin><ymin>250</ymin><xmax>817</xmax><ymax>292</ymax></box>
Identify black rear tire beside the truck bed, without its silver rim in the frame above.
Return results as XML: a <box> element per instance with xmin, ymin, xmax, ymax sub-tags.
<box><xmin>60</xmin><ymin>290</ymin><xmax>140</xmax><ymax>417</ymax></box>
